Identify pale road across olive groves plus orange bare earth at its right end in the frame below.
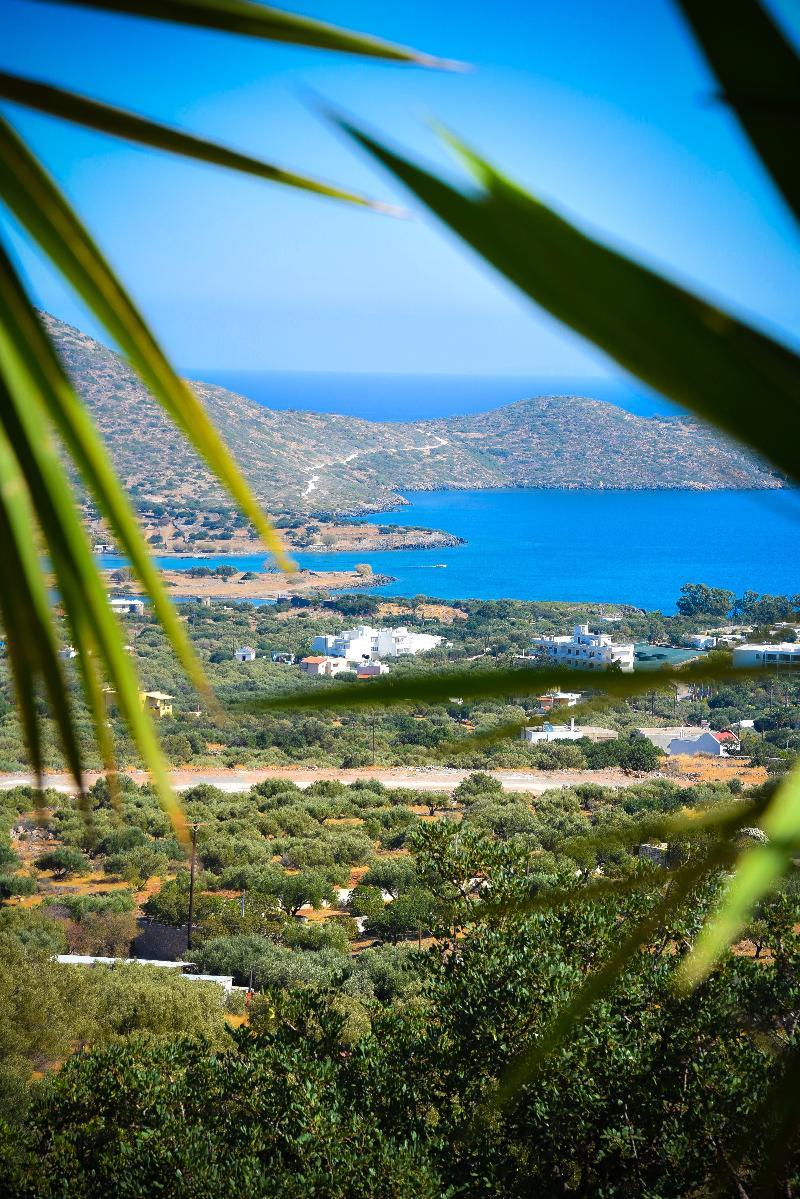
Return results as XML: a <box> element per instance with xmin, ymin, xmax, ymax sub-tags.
<box><xmin>0</xmin><ymin>758</ymin><xmax>766</xmax><ymax>795</ymax></box>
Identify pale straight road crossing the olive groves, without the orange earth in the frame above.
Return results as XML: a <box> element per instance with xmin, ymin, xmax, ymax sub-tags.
<box><xmin>0</xmin><ymin>766</ymin><xmax>676</xmax><ymax>795</ymax></box>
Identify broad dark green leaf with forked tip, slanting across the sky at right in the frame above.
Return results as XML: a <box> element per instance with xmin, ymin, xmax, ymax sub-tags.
<box><xmin>337</xmin><ymin>119</ymin><xmax>800</xmax><ymax>481</ymax></box>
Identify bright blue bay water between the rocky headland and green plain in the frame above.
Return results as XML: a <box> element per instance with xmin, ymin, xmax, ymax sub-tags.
<box><xmin>102</xmin><ymin>489</ymin><xmax>800</xmax><ymax>613</ymax></box>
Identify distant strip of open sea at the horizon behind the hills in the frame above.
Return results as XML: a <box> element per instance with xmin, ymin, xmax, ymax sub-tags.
<box><xmin>181</xmin><ymin>367</ymin><xmax>682</xmax><ymax>421</ymax></box>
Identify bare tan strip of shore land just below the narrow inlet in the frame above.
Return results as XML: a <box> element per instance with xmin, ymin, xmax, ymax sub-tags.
<box><xmin>103</xmin><ymin>571</ymin><xmax>395</xmax><ymax>600</ymax></box>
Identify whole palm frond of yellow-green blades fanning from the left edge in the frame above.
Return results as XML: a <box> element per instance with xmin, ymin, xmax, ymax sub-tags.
<box><xmin>0</xmin><ymin>0</ymin><xmax>445</xmax><ymax>832</ymax></box>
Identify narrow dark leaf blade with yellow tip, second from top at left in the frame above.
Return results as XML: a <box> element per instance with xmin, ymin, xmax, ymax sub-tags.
<box><xmin>0</xmin><ymin>71</ymin><xmax>397</xmax><ymax>212</ymax></box>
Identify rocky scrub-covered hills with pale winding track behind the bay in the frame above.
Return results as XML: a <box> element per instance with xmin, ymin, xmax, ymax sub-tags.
<box><xmin>43</xmin><ymin>315</ymin><xmax>783</xmax><ymax>513</ymax></box>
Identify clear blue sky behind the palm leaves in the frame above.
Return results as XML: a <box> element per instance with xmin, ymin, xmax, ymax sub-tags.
<box><xmin>0</xmin><ymin>0</ymin><xmax>800</xmax><ymax>379</ymax></box>
